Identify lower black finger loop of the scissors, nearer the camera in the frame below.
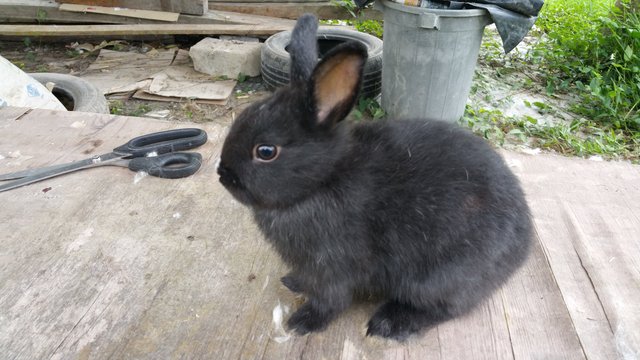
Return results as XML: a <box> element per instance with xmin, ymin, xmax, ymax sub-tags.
<box><xmin>129</xmin><ymin>152</ymin><xmax>202</xmax><ymax>179</ymax></box>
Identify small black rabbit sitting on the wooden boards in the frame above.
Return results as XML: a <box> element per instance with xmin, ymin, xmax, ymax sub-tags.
<box><xmin>218</xmin><ymin>14</ymin><xmax>532</xmax><ymax>340</ymax></box>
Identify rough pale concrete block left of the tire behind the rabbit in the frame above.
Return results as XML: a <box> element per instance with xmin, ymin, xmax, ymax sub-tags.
<box><xmin>189</xmin><ymin>38</ymin><xmax>262</xmax><ymax>79</ymax></box>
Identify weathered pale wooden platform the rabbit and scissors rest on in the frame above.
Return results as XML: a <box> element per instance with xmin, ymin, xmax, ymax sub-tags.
<box><xmin>0</xmin><ymin>108</ymin><xmax>640</xmax><ymax>360</ymax></box>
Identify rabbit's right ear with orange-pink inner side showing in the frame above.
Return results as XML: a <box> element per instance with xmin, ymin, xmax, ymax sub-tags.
<box><xmin>311</xmin><ymin>42</ymin><xmax>367</xmax><ymax>127</ymax></box>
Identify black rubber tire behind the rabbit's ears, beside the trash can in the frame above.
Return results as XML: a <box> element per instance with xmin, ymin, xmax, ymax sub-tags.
<box><xmin>260</xmin><ymin>27</ymin><xmax>382</xmax><ymax>98</ymax></box>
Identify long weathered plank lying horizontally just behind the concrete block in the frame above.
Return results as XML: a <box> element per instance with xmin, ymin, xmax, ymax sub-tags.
<box><xmin>0</xmin><ymin>24</ymin><xmax>292</xmax><ymax>37</ymax></box>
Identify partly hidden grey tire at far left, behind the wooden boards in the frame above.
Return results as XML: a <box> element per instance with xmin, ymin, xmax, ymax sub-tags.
<box><xmin>29</xmin><ymin>73</ymin><xmax>109</xmax><ymax>114</ymax></box>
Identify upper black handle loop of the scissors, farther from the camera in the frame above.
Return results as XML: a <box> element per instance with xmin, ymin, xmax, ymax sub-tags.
<box><xmin>113</xmin><ymin>128</ymin><xmax>207</xmax><ymax>157</ymax></box>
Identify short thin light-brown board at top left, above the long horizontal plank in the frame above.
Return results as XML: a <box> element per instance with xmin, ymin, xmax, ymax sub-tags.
<box><xmin>56</xmin><ymin>0</ymin><xmax>208</xmax><ymax>15</ymax></box>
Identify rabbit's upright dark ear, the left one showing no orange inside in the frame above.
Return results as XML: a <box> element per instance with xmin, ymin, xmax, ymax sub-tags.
<box><xmin>287</xmin><ymin>14</ymin><xmax>318</xmax><ymax>85</ymax></box>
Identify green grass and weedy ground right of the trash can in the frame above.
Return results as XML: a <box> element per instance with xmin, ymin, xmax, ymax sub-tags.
<box><xmin>461</xmin><ymin>0</ymin><xmax>640</xmax><ymax>163</ymax></box>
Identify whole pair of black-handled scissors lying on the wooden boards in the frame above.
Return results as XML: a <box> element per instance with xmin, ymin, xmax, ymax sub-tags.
<box><xmin>0</xmin><ymin>128</ymin><xmax>207</xmax><ymax>192</ymax></box>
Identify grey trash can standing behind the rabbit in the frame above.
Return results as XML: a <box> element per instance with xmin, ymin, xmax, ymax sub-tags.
<box><xmin>376</xmin><ymin>0</ymin><xmax>491</xmax><ymax>122</ymax></box>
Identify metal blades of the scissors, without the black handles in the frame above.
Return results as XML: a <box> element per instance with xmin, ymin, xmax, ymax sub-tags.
<box><xmin>0</xmin><ymin>153</ymin><xmax>122</xmax><ymax>192</ymax></box>
